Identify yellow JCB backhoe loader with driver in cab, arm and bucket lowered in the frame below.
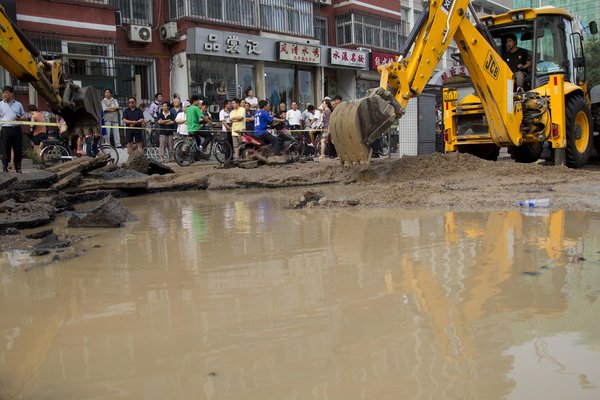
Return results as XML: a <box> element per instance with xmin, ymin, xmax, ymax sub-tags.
<box><xmin>330</xmin><ymin>0</ymin><xmax>600</xmax><ymax>168</ymax></box>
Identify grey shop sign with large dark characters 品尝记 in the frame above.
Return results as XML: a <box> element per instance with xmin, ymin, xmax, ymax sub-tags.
<box><xmin>187</xmin><ymin>28</ymin><xmax>276</xmax><ymax>61</ymax></box>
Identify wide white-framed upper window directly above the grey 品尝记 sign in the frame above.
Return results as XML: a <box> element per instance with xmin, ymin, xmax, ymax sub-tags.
<box><xmin>169</xmin><ymin>0</ymin><xmax>257</xmax><ymax>26</ymax></box>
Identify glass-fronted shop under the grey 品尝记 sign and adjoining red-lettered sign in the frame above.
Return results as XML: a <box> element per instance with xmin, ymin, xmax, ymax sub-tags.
<box><xmin>185</xmin><ymin>28</ymin><xmax>321</xmax><ymax>112</ymax></box>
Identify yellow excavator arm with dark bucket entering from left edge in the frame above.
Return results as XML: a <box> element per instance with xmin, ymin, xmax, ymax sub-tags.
<box><xmin>0</xmin><ymin>0</ymin><xmax>101</xmax><ymax>134</ymax></box>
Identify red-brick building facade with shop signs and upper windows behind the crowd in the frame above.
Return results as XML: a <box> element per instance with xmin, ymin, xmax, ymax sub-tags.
<box><xmin>8</xmin><ymin>0</ymin><xmax>405</xmax><ymax>115</ymax></box>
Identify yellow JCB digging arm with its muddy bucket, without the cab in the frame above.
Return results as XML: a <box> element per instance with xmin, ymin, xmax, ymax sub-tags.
<box><xmin>329</xmin><ymin>0</ymin><xmax>540</xmax><ymax>163</ymax></box>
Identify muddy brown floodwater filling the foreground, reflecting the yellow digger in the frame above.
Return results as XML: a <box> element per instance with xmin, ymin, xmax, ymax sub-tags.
<box><xmin>0</xmin><ymin>188</ymin><xmax>600</xmax><ymax>400</ymax></box>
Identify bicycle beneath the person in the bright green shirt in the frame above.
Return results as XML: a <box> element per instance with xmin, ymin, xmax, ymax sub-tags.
<box><xmin>173</xmin><ymin>132</ymin><xmax>233</xmax><ymax>167</ymax></box>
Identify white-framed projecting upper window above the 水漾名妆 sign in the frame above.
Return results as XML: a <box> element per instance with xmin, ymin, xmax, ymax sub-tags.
<box><xmin>336</xmin><ymin>14</ymin><xmax>401</xmax><ymax>51</ymax></box>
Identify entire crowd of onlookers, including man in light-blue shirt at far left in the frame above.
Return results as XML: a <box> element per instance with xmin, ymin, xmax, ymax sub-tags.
<box><xmin>0</xmin><ymin>86</ymin><xmax>342</xmax><ymax>172</ymax></box>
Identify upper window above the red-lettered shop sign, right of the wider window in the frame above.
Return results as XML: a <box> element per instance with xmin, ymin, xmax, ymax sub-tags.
<box><xmin>260</xmin><ymin>0</ymin><xmax>314</xmax><ymax>37</ymax></box>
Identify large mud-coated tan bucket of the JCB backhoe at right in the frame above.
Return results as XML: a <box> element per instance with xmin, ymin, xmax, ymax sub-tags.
<box><xmin>329</xmin><ymin>89</ymin><xmax>398</xmax><ymax>164</ymax></box>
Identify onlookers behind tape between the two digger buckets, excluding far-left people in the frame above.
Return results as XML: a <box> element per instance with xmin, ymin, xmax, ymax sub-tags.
<box><xmin>109</xmin><ymin>89</ymin><xmax>342</xmax><ymax>161</ymax></box>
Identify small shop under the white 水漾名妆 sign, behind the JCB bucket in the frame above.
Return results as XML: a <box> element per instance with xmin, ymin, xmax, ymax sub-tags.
<box><xmin>324</xmin><ymin>47</ymin><xmax>369</xmax><ymax>100</ymax></box>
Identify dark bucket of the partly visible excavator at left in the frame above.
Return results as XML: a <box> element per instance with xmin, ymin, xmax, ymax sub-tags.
<box><xmin>56</xmin><ymin>82</ymin><xmax>102</xmax><ymax>135</ymax></box>
